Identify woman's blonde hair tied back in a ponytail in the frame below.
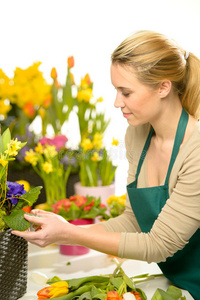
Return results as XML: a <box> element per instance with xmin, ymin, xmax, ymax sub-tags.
<box><xmin>111</xmin><ymin>31</ymin><xmax>200</xmax><ymax>118</ymax></box>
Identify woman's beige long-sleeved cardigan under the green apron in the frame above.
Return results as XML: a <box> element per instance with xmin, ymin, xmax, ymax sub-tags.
<box><xmin>102</xmin><ymin>123</ymin><xmax>200</xmax><ymax>263</ymax></box>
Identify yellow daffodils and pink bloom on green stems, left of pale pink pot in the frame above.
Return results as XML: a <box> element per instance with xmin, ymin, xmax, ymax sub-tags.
<box><xmin>25</xmin><ymin>135</ymin><xmax>72</xmax><ymax>205</ymax></box>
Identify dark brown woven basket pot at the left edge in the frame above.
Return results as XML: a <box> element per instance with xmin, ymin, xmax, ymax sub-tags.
<box><xmin>0</xmin><ymin>229</ymin><xmax>28</xmax><ymax>300</ymax></box>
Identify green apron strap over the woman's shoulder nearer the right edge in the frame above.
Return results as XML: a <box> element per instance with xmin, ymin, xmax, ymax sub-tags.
<box><xmin>165</xmin><ymin>108</ymin><xmax>189</xmax><ymax>185</ymax></box>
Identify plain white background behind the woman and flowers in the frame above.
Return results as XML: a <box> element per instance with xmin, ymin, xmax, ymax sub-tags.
<box><xmin>0</xmin><ymin>0</ymin><xmax>200</xmax><ymax>194</ymax></box>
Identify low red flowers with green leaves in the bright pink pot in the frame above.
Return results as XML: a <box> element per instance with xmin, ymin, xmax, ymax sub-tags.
<box><xmin>46</xmin><ymin>195</ymin><xmax>108</xmax><ymax>221</ymax></box>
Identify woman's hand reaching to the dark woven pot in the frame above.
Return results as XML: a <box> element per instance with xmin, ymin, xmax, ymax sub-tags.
<box><xmin>12</xmin><ymin>209</ymin><xmax>71</xmax><ymax>247</ymax></box>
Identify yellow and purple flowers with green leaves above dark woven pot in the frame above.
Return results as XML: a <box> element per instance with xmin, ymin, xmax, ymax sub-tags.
<box><xmin>0</xmin><ymin>129</ymin><xmax>42</xmax><ymax>231</ymax></box>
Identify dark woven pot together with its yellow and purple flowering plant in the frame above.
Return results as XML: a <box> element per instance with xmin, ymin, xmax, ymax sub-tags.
<box><xmin>0</xmin><ymin>129</ymin><xmax>42</xmax><ymax>299</ymax></box>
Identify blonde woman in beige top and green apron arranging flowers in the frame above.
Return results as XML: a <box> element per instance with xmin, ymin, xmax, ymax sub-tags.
<box><xmin>13</xmin><ymin>31</ymin><xmax>200</xmax><ymax>299</ymax></box>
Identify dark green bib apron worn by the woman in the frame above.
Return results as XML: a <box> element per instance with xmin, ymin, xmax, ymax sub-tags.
<box><xmin>127</xmin><ymin>110</ymin><xmax>200</xmax><ymax>299</ymax></box>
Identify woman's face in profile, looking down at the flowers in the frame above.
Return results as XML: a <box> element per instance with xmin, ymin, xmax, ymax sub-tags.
<box><xmin>111</xmin><ymin>64</ymin><xmax>161</xmax><ymax>126</ymax></box>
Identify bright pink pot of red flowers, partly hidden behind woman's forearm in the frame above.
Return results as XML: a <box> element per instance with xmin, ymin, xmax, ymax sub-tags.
<box><xmin>59</xmin><ymin>219</ymin><xmax>94</xmax><ymax>255</ymax></box>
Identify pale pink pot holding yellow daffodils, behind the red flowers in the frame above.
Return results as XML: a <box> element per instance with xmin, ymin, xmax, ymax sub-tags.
<box><xmin>74</xmin><ymin>182</ymin><xmax>115</xmax><ymax>205</ymax></box>
